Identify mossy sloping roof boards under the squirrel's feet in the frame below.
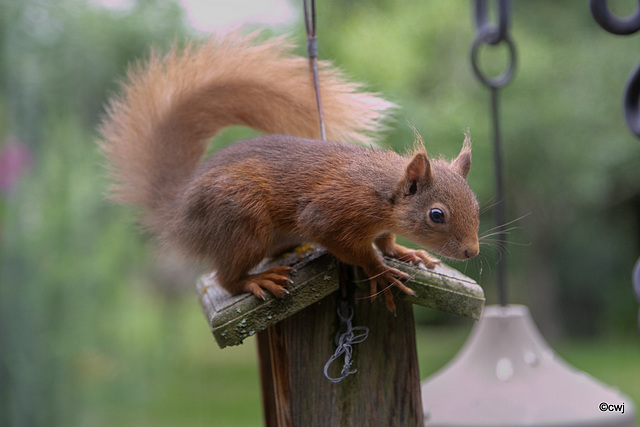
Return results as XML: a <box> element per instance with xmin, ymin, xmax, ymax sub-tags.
<box><xmin>197</xmin><ymin>246</ymin><xmax>484</xmax><ymax>348</ymax></box>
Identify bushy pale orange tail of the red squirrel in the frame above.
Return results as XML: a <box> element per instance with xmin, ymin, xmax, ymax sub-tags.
<box><xmin>101</xmin><ymin>33</ymin><xmax>392</xmax><ymax>236</ymax></box>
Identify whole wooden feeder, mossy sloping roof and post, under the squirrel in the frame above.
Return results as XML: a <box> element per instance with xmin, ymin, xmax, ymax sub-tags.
<box><xmin>198</xmin><ymin>246</ymin><xmax>484</xmax><ymax>427</ymax></box>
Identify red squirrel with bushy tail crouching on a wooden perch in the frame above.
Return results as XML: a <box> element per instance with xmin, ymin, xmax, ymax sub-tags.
<box><xmin>100</xmin><ymin>34</ymin><xmax>479</xmax><ymax>311</ymax></box>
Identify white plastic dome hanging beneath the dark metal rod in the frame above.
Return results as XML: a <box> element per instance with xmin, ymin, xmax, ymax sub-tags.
<box><xmin>421</xmin><ymin>305</ymin><xmax>636</xmax><ymax>427</ymax></box>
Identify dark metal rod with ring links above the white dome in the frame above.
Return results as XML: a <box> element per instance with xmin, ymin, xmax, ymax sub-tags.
<box><xmin>471</xmin><ymin>0</ymin><xmax>516</xmax><ymax>306</ymax></box>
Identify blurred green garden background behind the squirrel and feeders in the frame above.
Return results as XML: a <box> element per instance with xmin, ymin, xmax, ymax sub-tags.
<box><xmin>0</xmin><ymin>0</ymin><xmax>640</xmax><ymax>426</ymax></box>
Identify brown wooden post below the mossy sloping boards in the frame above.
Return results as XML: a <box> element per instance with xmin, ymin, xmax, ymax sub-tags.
<box><xmin>258</xmin><ymin>291</ymin><xmax>424</xmax><ymax>427</ymax></box>
